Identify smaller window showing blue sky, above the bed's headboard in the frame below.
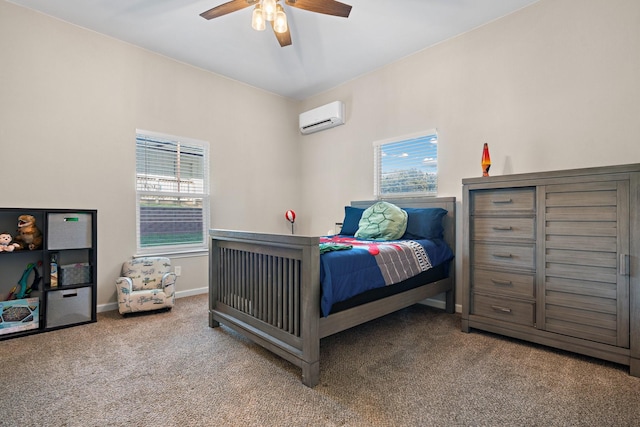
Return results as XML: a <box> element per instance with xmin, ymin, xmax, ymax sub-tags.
<box><xmin>373</xmin><ymin>129</ymin><xmax>438</xmax><ymax>198</ymax></box>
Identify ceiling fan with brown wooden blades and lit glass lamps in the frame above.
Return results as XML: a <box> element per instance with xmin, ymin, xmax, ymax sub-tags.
<box><xmin>200</xmin><ymin>0</ymin><xmax>351</xmax><ymax>47</ymax></box>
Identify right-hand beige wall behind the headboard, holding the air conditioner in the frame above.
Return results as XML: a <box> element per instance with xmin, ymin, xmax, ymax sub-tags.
<box><xmin>301</xmin><ymin>0</ymin><xmax>640</xmax><ymax>304</ymax></box>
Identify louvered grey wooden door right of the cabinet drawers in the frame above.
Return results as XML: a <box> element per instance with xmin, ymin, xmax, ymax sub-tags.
<box><xmin>538</xmin><ymin>181</ymin><xmax>629</xmax><ymax>348</ymax></box>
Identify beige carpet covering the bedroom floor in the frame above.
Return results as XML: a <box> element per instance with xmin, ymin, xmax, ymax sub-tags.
<box><xmin>0</xmin><ymin>295</ymin><xmax>640</xmax><ymax>426</ymax></box>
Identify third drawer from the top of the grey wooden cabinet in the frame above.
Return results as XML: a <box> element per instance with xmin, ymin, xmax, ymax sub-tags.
<box><xmin>472</xmin><ymin>242</ymin><xmax>536</xmax><ymax>270</ymax></box>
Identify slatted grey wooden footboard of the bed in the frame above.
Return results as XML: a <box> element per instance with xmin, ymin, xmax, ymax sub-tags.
<box><xmin>209</xmin><ymin>230</ymin><xmax>320</xmax><ymax>387</ymax></box>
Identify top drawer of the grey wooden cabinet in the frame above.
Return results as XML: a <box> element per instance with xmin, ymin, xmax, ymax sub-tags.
<box><xmin>471</xmin><ymin>187</ymin><xmax>536</xmax><ymax>215</ymax></box>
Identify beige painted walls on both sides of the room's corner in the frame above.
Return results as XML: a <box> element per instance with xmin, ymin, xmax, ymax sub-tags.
<box><xmin>0</xmin><ymin>0</ymin><xmax>640</xmax><ymax>305</ymax></box>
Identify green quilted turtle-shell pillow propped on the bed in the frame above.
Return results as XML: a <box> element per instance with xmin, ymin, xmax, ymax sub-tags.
<box><xmin>355</xmin><ymin>202</ymin><xmax>407</xmax><ymax>240</ymax></box>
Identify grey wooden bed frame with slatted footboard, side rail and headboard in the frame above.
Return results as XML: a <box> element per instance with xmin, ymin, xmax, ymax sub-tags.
<box><xmin>209</xmin><ymin>197</ymin><xmax>456</xmax><ymax>387</ymax></box>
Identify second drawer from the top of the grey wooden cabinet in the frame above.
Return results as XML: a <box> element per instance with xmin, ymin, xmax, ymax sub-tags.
<box><xmin>471</xmin><ymin>217</ymin><xmax>535</xmax><ymax>240</ymax></box>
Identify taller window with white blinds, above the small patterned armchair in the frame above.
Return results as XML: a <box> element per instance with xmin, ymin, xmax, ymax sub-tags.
<box><xmin>136</xmin><ymin>130</ymin><xmax>209</xmax><ymax>254</ymax></box>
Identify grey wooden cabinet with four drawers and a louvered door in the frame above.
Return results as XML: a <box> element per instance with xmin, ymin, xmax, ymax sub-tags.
<box><xmin>462</xmin><ymin>164</ymin><xmax>640</xmax><ymax>376</ymax></box>
